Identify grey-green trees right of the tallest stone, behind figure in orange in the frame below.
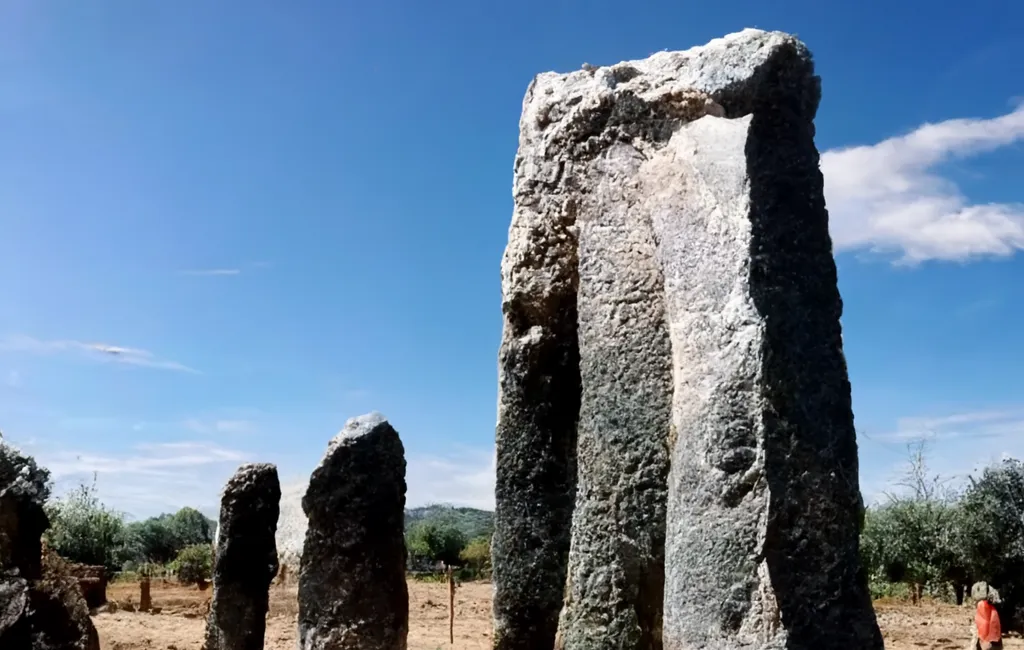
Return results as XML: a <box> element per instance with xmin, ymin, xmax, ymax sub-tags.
<box><xmin>860</xmin><ymin>443</ymin><xmax>1024</xmax><ymax>621</ymax></box>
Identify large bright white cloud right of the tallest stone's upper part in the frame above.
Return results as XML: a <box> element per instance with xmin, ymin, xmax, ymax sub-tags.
<box><xmin>821</xmin><ymin>104</ymin><xmax>1024</xmax><ymax>264</ymax></box>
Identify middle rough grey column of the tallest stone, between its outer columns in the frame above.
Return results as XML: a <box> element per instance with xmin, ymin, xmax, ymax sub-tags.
<box><xmin>556</xmin><ymin>143</ymin><xmax>672</xmax><ymax>649</ymax></box>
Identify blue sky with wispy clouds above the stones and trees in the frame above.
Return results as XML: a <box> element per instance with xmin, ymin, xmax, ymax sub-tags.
<box><xmin>0</xmin><ymin>0</ymin><xmax>1024</xmax><ymax>517</ymax></box>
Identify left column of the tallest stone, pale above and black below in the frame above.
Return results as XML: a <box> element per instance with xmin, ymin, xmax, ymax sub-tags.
<box><xmin>490</xmin><ymin>73</ymin><xmax>580</xmax><ymax>650</ymax></box>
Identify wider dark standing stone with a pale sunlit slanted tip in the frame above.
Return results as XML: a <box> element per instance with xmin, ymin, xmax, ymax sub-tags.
<box><xmin>299</xmin><ymin>414</ymin><xmax>409</xmax><ymax>650</ymax></box>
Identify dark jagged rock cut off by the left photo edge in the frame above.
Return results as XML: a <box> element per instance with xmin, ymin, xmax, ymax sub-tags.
<box><xmin>0</xmin><ymin>440</ymin><xmax>99</xmax><ymax>650</ymax></box>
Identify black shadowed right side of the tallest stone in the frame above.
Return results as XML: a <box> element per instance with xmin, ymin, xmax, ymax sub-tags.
<box><xmin>745</xmin><ymin>40</ymin><xmax>883</xmax><ymax>650</ymax></box>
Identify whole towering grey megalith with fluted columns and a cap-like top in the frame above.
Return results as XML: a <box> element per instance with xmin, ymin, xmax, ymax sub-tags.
<box><xmin>494</xmin><ymin>30</ymin><xmax>882</xmax><ymax>650</ymax></box>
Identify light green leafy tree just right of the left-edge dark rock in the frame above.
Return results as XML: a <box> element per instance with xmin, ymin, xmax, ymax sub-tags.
<box><xmin>45</xmin><ymin>477</ymin><xmax>141</xmax><ymax>571</ymax></box>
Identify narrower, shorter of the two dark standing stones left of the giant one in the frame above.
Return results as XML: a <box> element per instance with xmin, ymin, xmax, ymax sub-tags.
<box><xmin>205</xmin><ymin>464</ymin><xmax>281</xmax><ymax>650</ymax></box>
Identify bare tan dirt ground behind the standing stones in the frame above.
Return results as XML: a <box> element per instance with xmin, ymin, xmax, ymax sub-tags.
<box><xmin>93</xmin><ymin>580</ymin><xmax>1024</xmax><ymax>650</ymax></box>
